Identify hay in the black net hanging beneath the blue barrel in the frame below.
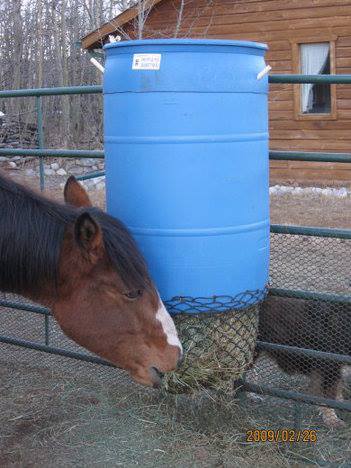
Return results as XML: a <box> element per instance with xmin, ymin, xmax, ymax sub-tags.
<box><xmin>163</xmin><ymin>305</ymin><xmax>258</xmax><ymax>393</ymax></box>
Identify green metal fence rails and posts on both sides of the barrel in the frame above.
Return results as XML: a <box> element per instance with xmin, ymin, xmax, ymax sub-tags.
<box><xmin>0</xmin><ymin>75</ymin><xmax>351</xmax><ymax>411</ymax></box>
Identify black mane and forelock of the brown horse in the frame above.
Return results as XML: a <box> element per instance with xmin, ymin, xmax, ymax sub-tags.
<box><xmin>0</xmin><ymin>173</ymin><xmax>151</xmax><ymax>296</ymax></box>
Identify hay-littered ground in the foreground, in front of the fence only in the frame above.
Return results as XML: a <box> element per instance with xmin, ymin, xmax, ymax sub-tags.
<box><xmin>0</xmin><ymin>356</ymin><xmax>351</xmax><ymax>467</ymax></box>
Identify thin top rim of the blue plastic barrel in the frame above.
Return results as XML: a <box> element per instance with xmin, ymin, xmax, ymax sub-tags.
<box><xmin>103</xmin><ymin>39</ymin><xmax>268</xmax><ymax>50</ymax></box>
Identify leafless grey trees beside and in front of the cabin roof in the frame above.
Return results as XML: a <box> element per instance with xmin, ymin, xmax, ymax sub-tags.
<box><xmin>0</xmin><ymin>0</ymin><xmax>213</xmax><ymax>148</ymax></box>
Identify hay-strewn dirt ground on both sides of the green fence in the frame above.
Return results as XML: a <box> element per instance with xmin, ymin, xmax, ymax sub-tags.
<box><xmin>0</xmin><ymin>173</ymin><xmax>351</xmax><ymax>468</ymax></box>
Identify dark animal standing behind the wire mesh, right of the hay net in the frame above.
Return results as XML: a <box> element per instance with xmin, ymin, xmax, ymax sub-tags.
<box><xmin>256</xmin><ymin>296</ymin><xmax>351</xmax><ymax>426</ymax></box>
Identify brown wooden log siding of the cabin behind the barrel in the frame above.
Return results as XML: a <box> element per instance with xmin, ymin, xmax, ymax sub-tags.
<box><xmin>120</xmin><ymin>0</ymin><xmax>351</xmax><ymax>186</ymax></box>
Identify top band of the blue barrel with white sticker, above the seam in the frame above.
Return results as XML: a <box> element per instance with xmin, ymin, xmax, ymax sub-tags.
<box><xmin>104</xmin><ymin>39</ymin><xmax>268</xmax><ymax>94</ymax></box>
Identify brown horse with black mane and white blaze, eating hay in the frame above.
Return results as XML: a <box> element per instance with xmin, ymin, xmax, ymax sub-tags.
<box><xmin>0</xmin><ymin>174</ymin><xmax>182</xmax><ymax>387</ymax></box>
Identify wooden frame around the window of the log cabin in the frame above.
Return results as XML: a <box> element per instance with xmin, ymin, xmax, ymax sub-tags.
<box><xmin>291</xmin><ymin>36</ymin><xmax>337</xmax><ymax>120</ymax></box>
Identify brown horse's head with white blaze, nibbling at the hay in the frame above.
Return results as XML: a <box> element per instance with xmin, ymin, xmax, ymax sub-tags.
<box><xmin>52</xmin><ymin>177</ymin><xmax>182</xmax><ymax>387</ymax></box>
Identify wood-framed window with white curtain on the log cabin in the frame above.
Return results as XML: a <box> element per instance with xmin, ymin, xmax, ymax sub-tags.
<box><xmin>291</xmin><ymin>37</ymin><xmax>337</xmax><ymax>120</ymax></box>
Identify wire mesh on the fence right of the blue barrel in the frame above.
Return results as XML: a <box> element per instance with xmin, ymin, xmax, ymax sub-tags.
<box><xmin>247</xmin><ymin>234</ymin><xmax>351</xmax><ymax>426</ymax></box>
